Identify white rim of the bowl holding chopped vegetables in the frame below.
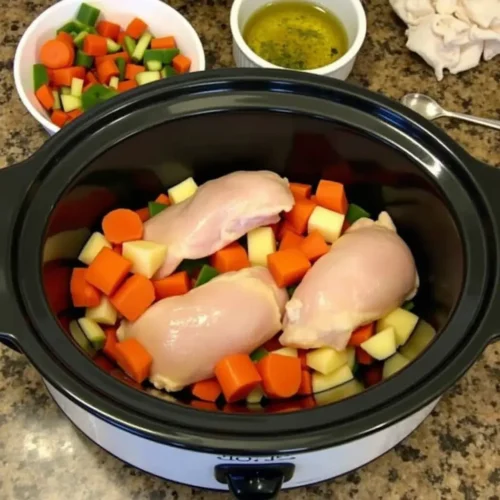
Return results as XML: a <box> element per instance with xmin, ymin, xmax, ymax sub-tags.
<box><xmin>13</xmin><ymin>0</ymin><xmax>206</xmax><ymax>133</ymax></box>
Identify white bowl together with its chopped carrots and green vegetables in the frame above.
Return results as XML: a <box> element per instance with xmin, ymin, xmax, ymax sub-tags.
<box><xmin>14</xmin><ymin>0</ymin><xmax>205</xmax><ymax>134</ymax></box>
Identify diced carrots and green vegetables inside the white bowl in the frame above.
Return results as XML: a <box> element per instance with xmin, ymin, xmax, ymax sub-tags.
<box><xmin>33</xmin><ymin>3</ymin><xmax>191</xmax><ymax>127</ymax></box>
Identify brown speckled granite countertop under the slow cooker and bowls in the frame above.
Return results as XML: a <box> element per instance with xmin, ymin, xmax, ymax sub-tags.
<box><xmin>0</xmin><ymin>0</ymin><xmax>500</xmax><ymax>500</ymax></box>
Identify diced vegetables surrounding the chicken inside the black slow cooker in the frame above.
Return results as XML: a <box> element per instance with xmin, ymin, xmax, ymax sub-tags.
<box><xmin>48</xmin><ymin>176</ymin><xmax>435</xmax><ymax>409</ymax></box>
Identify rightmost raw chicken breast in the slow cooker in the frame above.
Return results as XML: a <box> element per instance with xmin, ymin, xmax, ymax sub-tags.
<box><xmin>280</xmin><ymin>212</ymin><xmax>418</xmax><ymax>351</ymax></box>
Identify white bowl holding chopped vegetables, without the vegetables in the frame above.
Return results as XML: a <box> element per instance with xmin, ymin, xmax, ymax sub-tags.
<box><xmin>14</xmin><ymin>0</ymin><xmax>205</xmax><ymax>135</ymax></box>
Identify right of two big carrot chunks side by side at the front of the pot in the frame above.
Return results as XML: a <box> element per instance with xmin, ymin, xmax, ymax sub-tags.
<box><xmin>256</xmin><ymin>353</ymin><xmax>302</xmax><ymax>398</ymax></box>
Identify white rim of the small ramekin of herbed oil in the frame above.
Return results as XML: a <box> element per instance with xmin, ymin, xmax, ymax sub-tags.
<box><xmin>230</xmin><ymin>0</ymin><xmax>367</xmax><ymax>76</ymax></box>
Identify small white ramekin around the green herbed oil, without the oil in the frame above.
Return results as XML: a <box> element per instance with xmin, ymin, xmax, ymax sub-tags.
<box><xmin>231</xmin><ymin>0</ymin><xmax>366</xmax><ymax>80</ymax></box>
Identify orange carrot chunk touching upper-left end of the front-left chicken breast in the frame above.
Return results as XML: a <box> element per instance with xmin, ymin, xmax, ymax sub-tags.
<box><xmin>109</xmin><ymin>274</ymin><xmax>155</xmax><ymax>321</ymax></box>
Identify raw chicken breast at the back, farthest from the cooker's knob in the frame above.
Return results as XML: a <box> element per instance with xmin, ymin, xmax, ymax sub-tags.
<box><xmin>144</xmin><ymin>170</ymin><xmax>294</xmax><ymax>278</ymax></box>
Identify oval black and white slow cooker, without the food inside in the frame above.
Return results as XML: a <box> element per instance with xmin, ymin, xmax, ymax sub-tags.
<box><xmin>0</xmin><ymin>70</ymin><xmax>500</xmax><ymax>498</ymax></box>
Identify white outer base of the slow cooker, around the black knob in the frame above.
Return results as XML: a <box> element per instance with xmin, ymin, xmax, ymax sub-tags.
<box><xmin>45</xmin><ymin>382</ymin><xmax>439</xmax><ymax>491</ymax></box>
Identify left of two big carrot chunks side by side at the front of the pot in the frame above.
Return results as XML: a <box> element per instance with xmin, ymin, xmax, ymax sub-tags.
<box><xmin>214</xmin><ymin>354</ymin><xmax>262</xmax><ymax>403</ymax></box>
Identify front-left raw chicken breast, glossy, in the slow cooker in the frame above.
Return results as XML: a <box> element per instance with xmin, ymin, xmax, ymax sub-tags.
<box><xmin>118</xmin><ymin>267</ymin><xmax>288</xmax><ymax>391</ymax></box>
